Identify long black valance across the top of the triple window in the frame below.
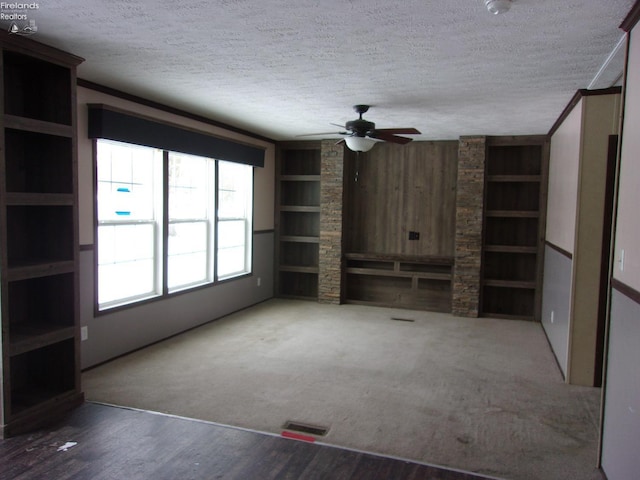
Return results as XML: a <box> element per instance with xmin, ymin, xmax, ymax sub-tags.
<box><xmin>88</xmin><ymin>104</ymin><xmax>264</xmax><ymax>167</ymax></box>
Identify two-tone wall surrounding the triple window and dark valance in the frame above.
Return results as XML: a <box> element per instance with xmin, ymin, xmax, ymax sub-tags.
<box><xmin>78</xmin><ymin>87</ymin><xmax>275</xmax><ymax>368</ymax></box>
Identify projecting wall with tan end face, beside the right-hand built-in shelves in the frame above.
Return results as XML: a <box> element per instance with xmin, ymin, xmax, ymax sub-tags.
<box><xmin>541</xmin><ymin>91</ymin><xmax>620</xmax><ymax>386</ymax></box>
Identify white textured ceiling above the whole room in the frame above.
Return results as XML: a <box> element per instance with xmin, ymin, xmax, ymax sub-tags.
<box><xmin>6</xmin><ymin>0</ymin><xmax>634</xmax><ymax>140</ymax></box>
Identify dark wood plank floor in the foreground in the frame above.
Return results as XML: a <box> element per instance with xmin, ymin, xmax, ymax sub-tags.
<box><xmin>0</xmin><ymin>403</ymin><xmax>496</xmax><ymax>480</ymax></box>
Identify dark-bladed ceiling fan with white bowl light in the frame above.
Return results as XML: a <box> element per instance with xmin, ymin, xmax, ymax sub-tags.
<box><xmin>302</xmin><ymin>105</ymin><xmax>420</xmax><ymax>152</ymax></box>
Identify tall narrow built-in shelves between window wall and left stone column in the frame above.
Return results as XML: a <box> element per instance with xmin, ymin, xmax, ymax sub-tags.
<box><xmin>276</xmin><ymin>142</ymin><xmax>320</xmax><ymax>299</ymax></box>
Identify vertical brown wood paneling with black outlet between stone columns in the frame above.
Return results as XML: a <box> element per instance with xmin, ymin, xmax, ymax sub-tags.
<box><xmin>344</xmin><ymin>141</ymin><xmax>458</xmax><ymax>256</ymax></box>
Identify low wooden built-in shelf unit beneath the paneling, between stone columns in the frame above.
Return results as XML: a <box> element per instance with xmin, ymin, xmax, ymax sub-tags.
<box><xmin>345</xmin><ymin>253</ymin><xmax>453</xmax><ymax>312</ymax></box>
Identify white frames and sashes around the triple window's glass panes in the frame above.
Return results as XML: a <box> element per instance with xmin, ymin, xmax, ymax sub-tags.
<box><xmin>92</xmin><ymin>137</ymin><xmax>255</xmax><ymax>317</ymax></box>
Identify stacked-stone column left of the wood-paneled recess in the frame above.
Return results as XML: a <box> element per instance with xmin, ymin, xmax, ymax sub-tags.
<box><xmin>318</xmin><ymin>140</ymin><xmax>344</xmax><ymax>304</ymax></box>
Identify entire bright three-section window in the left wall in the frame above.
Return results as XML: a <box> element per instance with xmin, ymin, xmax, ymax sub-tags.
<box><xmin>96</xmin><ymin>139</ymin><xmax>253</xmax><ymax>310</ymax></box>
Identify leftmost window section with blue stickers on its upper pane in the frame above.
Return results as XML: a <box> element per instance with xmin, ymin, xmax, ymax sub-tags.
<box><xmin>97</xmin><ymin>141</ymin><xmax>162</xmax><ymax>307</ymax></box>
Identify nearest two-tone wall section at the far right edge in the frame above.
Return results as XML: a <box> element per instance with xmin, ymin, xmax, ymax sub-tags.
<box><xmin>602</xmin><ymin>26</ymin><xmax>640</xmax><ymax>480</ymax></box>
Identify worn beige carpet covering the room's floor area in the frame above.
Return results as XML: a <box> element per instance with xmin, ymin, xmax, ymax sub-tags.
<box><xmin>83</xmin><ymin>299</ymin><xmax>602</xmax><ymax>480</ymax></box>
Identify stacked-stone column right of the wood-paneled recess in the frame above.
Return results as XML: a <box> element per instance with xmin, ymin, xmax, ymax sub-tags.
<box><xmin>451</xmin><ymin>137</ymin><xmax>487</xmax><ymax>317</ymax></box>
